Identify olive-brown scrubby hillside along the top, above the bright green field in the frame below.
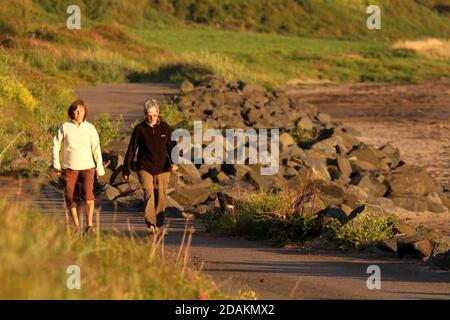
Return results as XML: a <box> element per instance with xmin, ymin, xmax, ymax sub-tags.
<box><xmin>142</xmin><ymin>0</ymin><xmax>450</xmax><ymax>41</ymax></box>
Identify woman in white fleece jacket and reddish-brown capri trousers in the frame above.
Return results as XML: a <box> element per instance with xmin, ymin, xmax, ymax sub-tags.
<box><xmin>52</xmin><ymin>100</ymin><xmax>105</xmax><ymax>233</ymax></box>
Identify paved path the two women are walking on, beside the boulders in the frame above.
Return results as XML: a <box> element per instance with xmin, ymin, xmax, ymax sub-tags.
<box><xmin>4</xmin><ymin>84</ymin><xmax>450</xmax><ymax>299</ymax></box>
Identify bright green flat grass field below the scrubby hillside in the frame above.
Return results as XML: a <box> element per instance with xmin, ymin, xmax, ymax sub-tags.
<box><xmin>131</xmin><ymin>28</ymin><xmax>450</xmax><ymax>85</ymax></box>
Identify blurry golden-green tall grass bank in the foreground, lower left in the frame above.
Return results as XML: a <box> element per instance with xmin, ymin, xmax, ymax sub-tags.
<box><xmin>0</xmin><ymin>201</ymin><xmax>229</xmax><ymax>299</ymax></box>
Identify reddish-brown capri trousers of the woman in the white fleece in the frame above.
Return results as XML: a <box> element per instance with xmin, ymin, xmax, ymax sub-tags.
<box><xmin>62</xmin><ymin>168</ymin><xmax>95</xmax><ymax>208</ymax></box>
